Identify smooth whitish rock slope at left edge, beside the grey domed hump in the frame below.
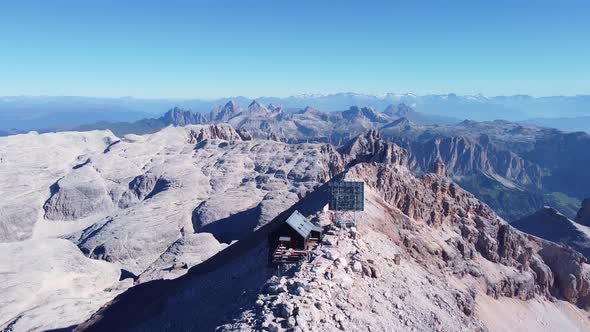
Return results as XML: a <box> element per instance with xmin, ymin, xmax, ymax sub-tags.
<box><xmin>0</xmin><ymin>130</ymin><xmax>117</xmax><ymax>242</ymax></box>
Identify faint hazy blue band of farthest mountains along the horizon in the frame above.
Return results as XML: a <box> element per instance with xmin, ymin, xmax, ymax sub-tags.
<box><xmin>0</xmin><ymin>93</ymin><xmax>590</xmax><ymax>135</ymax></box>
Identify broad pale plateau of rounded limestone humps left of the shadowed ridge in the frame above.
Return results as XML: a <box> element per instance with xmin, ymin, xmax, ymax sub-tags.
<box><xmin>0</xmin><ymin>125</ymin><xmax>340</xmax><ymax>275</ymax></box>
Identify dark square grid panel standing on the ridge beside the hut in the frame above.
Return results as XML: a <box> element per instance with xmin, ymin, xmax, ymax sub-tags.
<box><xmin>329</xmin><ymin>181</ymin><xmax>365</xmax><ymax>211</ymax></box>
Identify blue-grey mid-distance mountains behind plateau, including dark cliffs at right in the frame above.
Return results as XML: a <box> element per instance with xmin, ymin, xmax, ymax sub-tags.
<box><xmin>68</xmin><ymin>101</ymin><xmax>590</xmax><ymax>220</ymax></box>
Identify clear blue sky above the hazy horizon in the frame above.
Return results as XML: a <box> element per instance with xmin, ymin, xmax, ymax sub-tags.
<box><xmin>0</xmin><ymin>0</ymin><xmax>590</xmax><ymax>98</ymax></box>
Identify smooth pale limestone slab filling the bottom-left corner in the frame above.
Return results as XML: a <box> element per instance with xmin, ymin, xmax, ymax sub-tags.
<box><xmin>0</xmin><ymin>239</ymin><xmax>130</xmax><ymax>331</ymax></box>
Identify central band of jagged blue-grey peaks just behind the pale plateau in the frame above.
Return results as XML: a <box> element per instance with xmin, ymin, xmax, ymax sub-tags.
<box><xmin>72</xmin><ymin>100</ymin><xmax>460</xmax><ymax>139</ymax></box>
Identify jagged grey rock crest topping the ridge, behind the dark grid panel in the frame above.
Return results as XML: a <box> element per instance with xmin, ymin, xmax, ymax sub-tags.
<box><xmin>340</xmin><ymin>129</ymin><xmax>408</xmax><ymax>166</ymax></box>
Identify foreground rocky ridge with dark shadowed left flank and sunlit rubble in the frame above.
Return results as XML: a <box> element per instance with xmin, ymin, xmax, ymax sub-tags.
<box><xmin>78</xmin><ymin>133</ymin><xmax>590</xmax><ymax>331</ymax></box>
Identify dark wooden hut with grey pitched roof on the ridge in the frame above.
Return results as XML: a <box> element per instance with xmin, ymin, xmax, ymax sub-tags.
<box><xmin>269</xmin><ymin>210</ymin><xmax>323</xmax><ymax>263</ymax></box>
